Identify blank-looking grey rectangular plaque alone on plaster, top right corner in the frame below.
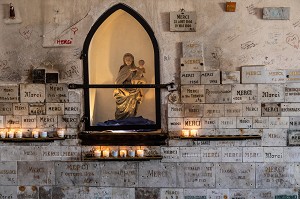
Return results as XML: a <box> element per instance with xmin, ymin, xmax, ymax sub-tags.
<box><xmin>263</xmin><ymin>7</ymin><xmax>290</xmax><ymax>20</ymax></box>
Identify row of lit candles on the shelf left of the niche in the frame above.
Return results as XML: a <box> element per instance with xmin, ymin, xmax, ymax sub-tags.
<box><xmin>0</xmin><ymin>129</ymin><xmax>65</xmax><ymax>138</ymax></box>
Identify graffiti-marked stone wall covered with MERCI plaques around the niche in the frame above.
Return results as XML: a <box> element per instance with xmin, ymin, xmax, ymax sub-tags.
<box><xmin>0</xmin><ymin>0</ymin><xmax>300</xmax><ymax>199</ymax></box>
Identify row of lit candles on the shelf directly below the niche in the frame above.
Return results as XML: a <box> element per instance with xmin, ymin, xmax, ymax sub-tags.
<box><xmin>94</xmin><ymin>149</ymin><xmax>144</xmax><ymax>158</ymax></box>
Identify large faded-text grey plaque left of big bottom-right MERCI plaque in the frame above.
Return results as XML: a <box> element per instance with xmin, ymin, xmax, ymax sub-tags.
<box><xmin>216</xmin><ymin>163</ymin><xmax>255</xmax><ymax>189</ymax></box>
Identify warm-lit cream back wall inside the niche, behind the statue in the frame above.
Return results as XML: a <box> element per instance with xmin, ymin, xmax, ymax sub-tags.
<box><xmin>88</xmin><ymin>9</ymin><xmax>156</xmax><ymax>126</ymax></box>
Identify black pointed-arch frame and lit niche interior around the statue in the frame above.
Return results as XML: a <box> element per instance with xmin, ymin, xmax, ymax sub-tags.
<box><xmin>82</xmin><ymin>3</ymin><xmax>161</xmax><ymax>145</ymax></box>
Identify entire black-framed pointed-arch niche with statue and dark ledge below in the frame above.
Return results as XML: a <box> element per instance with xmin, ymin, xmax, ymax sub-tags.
<box><xmin>79</xmin><ymin>3</ymin><xmax>166</xmax><ymax>145</ymax></box>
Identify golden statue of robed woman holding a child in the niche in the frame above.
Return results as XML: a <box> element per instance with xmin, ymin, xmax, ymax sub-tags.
<box><xmin>113</xmin><ymin>53</ymin><xmax>146</xmax><ymax>120</ymax></box>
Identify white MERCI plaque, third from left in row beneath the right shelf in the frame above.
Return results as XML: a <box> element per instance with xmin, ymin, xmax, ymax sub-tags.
<box><xmin>200</xmin><ymin>147</ymin><xmax>222</xmax><ymax>162</ymax></box>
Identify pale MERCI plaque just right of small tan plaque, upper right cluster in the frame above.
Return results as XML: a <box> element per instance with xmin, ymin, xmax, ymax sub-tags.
<box><xmin>241</xmin><ymin>65</ymin><xmax>266</xmax><ymax>84</ymax></box>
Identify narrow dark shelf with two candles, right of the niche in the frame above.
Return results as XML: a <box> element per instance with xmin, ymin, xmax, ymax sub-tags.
<box><xmin>180</xmin><ymin>135</ymin><xmax>261</xmax><ymax>140</ymax></box>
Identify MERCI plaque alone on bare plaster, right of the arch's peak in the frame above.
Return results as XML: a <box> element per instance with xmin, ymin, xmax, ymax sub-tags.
<box><xmin>170</xmin><ymin>9</ymin><xmax>197</xmax><ymax>32</ymax></box>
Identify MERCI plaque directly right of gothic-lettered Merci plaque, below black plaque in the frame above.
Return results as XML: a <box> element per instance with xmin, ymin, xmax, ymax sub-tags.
<box><xmin>46</xmin><ymin>84</ymin><xmax>69</xmax><ymax>102</ymax></box>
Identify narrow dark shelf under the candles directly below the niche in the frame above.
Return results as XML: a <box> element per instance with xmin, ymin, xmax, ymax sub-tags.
<box><xmin>84</xmin><ymin>156</ymin><xmax>162</xmax><ymax>161</ymax></box>
